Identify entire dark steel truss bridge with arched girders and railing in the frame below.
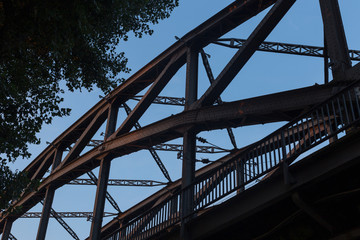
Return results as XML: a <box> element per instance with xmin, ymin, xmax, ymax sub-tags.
<box><xmin>0</xmin><ymin>0</ymin><xmax>360</xmax><ymax>240</ymax></box>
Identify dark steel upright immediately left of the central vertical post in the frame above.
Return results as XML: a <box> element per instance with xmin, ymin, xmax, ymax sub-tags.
<box><xmin>90</xmin><ymin>104</ymin><xmax>119</xmax><ymax>240</ymax></box>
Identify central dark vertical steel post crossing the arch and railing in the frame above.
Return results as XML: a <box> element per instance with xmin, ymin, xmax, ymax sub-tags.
<box><xmin>180</xmin><ymin>47</ymin><xmax>199</xmax><ymax>239</ymax></box>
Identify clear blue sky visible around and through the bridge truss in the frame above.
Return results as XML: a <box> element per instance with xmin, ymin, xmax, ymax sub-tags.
<box><xmin>7</xmin><ymin>0</ymin><xmax>360</xmax><ymax>240</ymax></box>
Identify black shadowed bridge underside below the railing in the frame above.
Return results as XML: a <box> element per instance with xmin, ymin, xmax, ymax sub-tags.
<box><xmin>155</xmin><ymin>131</ymin><xmax>360</xmax><ymax>239</ymax></box>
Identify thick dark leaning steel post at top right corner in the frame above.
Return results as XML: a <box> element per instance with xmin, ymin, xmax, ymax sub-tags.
<box><xmin>320</xmin><ymin>0</ymin><xmax>351</xmax><ymax>80</ymax></box>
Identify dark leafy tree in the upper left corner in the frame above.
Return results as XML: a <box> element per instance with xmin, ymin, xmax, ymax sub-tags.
<box><xmin>0</xmin><ymin>0</ymin><xmax>178</xmax><ymax>209</ymax></box>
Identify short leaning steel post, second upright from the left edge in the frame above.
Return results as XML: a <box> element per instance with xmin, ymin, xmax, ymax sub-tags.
<box><xmin>36</xmin><ymin>148</ymin><xmax>63</xmax><ymax>240</ymax></box>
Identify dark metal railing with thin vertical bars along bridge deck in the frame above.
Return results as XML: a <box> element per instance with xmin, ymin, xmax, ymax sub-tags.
<box><xmin>105</xmin><ymin>81</ymin><xmax>360</xmax><ymax>240</ymax></box>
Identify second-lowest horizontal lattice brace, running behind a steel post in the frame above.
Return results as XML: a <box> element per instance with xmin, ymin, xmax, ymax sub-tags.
<box><xmin>68</xmin><ymin>178</ymin><xmax>167</xmax><ymax>187</ymax></box>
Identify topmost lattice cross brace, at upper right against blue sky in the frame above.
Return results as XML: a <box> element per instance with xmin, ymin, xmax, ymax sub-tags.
<box><xmin>213</xmin><ymin>38</ymin><xmax>360</xmax><ymax>61</ymax></box>
